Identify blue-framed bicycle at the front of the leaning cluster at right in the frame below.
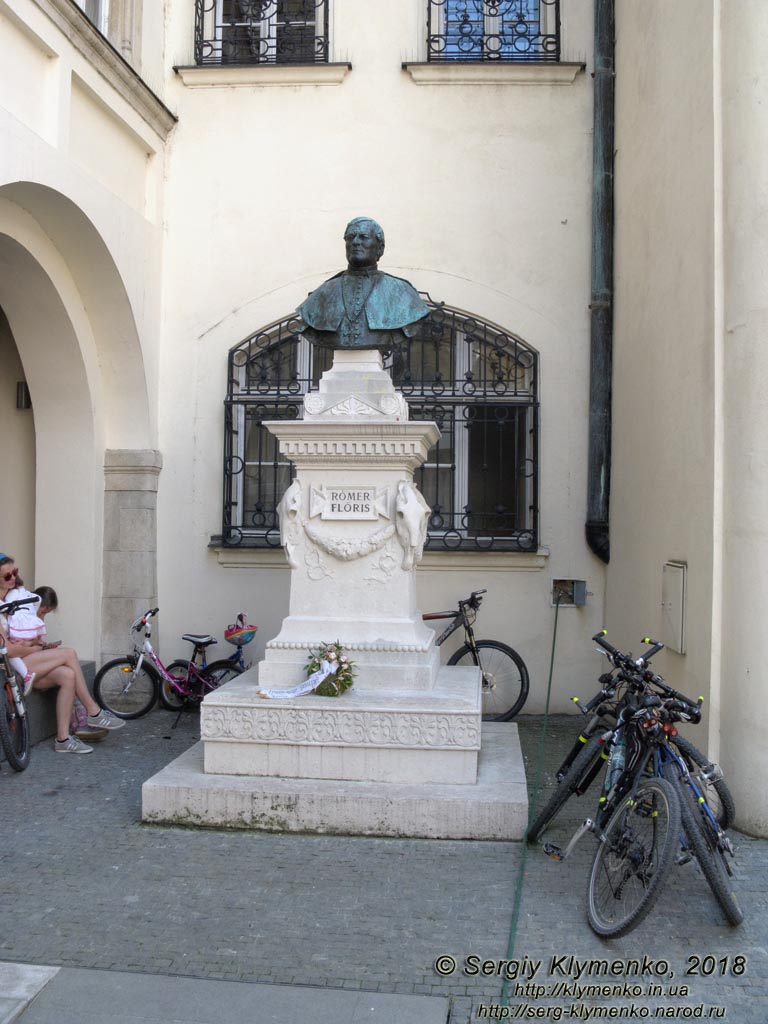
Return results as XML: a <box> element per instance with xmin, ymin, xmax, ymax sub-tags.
<box><xmin>544</xmin><ymin>634</ymin><xmax>743</xmax><ymax>938</ymax></box>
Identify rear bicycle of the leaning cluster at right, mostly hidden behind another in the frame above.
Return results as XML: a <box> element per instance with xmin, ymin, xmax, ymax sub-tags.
<box><xmin>527</xmin><ymin>630</ymin><xmax>736</xmax><ymax>842</ymax></box>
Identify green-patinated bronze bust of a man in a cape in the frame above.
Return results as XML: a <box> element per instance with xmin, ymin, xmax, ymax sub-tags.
<box><xmin>296</xmin><ymin>217</ymin><xmax>429</xmax><ymax>351</ymax></box>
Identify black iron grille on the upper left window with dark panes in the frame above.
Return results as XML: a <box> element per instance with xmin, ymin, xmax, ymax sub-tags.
<box><xmin>195</xmin><ymin>0</ymin><xmax>329</xmax><ymax>65</ymax></box>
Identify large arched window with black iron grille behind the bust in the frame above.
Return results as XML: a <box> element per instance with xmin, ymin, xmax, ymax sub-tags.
<box><xmin>215</xmin><ymin>295</ymin><xmax>539</xmax><ymax>551</ymax></box>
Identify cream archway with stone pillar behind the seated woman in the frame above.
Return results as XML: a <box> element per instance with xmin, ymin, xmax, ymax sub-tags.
<box><xmin>0</xmin><ymin>182</ymin><xmax>159</xmax><ymax>657</ymax></box>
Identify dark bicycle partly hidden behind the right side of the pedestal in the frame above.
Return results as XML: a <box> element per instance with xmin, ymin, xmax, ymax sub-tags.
<box><xmin>422</xmin><ymin>590</ymin><xmax>529</xmax><ymax>722</ymax></box>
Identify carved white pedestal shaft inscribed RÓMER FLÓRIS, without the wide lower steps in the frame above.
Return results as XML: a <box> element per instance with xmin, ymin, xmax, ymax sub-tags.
<box><xmin>258</xmin><ymin>350</ymin><xmax>439</xmax><ymax>690</ymax></box>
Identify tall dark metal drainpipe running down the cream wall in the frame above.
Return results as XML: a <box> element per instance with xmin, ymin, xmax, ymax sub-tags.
<box><xmin>586</xmin><ymin>0</ymin><xmax>615</xmax><ymax>562</ymax></box>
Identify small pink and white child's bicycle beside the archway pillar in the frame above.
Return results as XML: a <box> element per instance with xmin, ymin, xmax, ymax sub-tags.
<box><xmin>93</xmin><ymin>608</ymin><xmax>242</xmax><ymax>719</ymax></box>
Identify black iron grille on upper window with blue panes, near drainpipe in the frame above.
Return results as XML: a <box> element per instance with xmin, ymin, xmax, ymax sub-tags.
<box><xmin>427</xmin><ymin>0</ymin><xmax>560</xmax><ymax>61</ymax></box>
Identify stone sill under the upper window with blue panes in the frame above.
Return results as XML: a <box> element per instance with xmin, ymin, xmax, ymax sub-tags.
<box><xmin>402</xmin><ymin>60</ymin><xmax>587</xmax><ymax>85</ymax></box>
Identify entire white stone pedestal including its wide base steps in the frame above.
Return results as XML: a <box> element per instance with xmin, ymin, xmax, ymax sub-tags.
<box><xmin>142</xmin><ymin>351</ymin><xmax>527</xmax><ymax>839</ymax></box>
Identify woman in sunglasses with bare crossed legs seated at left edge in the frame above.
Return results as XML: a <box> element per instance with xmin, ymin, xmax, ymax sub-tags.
<box><xmin>0</xmin><ymin>554</ymin><xmax>125</xmax><ymax>754</ymax></box>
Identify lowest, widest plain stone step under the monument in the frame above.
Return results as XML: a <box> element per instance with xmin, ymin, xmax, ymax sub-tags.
<box><xmin>141</xmin><ymin>722</ymin><xmax>528</xmax><ymax>840</ymax></box>
